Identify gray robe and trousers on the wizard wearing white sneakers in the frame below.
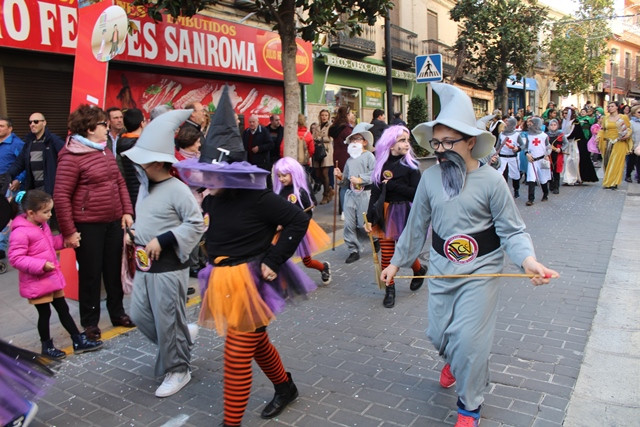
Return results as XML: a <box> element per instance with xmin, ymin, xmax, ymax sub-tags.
<box><xmin>131</xmin><ymin>178</ymin><xmax>204</xmax><ymax>376</ymax></box>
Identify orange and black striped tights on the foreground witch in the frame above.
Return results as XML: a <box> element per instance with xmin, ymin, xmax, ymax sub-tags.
<box><xmin>224</xmin><ymin>327</ymin><xmax>288</xmax><ymax>426</ymax></box>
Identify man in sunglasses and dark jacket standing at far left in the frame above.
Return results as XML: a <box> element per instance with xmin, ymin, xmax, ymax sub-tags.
<box><xmin>7</xmin><ymin>112</ymin><xmax>64</xmax><ymax>195</ymax></box>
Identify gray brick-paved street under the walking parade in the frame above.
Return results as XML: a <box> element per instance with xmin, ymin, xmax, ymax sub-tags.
<box><xmin>2</xmin><ymin>176</ymin><xmax>637</xmax><ymax>427</ymax></box>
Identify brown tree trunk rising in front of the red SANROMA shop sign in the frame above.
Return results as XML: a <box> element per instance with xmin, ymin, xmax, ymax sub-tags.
<box><xmin>278</xmin><ymin>0</ymin><xmax>300</xmax><ymax>159</ymax></box>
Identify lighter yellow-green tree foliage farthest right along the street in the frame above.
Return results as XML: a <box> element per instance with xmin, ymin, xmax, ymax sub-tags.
<box><xmin>546</xmin><ymin>0</ymin><xmax>613</xmax><ymax>95</ymax></box>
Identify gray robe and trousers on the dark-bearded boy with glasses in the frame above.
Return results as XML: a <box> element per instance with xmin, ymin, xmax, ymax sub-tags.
<box><xmin>391</xmin><ymin>165</ymin><xmax>535</xmax><ymax>410</ymax></box>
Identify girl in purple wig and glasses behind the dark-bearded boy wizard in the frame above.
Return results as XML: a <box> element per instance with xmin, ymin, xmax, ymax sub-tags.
<box><xmin>365</xmin><ymin>125</ymin><xmax>427</xmax><ymax>308</ymax></box>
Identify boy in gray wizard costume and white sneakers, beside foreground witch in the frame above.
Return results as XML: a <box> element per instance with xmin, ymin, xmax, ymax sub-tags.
<box><xmin>122</xmin><ymin>110</ymin><xmax>204</xmax><ymax>397</ymax></box>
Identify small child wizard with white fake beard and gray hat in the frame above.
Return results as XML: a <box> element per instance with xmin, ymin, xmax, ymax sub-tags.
<box><xmin>333</xmin><ymin>123</ymin><xmax>376</xmax><ymax>264</ymax></box>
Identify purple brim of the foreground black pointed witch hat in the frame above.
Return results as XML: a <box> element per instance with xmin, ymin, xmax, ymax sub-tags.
<box><xmin>173</xmin><ymin>159</ymin><xmax>269</xmax><ymax>190</ymax></box>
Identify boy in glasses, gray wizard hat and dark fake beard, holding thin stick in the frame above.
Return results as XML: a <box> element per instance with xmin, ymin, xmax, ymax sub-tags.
<box><xmin>381</xmin><ymin>83</ymin><xmax>558</xmax><ymax>427</ymax></box>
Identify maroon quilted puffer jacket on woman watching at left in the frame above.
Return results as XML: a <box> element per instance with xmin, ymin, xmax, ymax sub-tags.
<box><xmin>53</xmin><ymin>138</ymin><xmax>133</xmax><ymax>236</ymax></box>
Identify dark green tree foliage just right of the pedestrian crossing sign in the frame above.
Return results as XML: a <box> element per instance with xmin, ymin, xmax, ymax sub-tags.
<box><xmin>450</xmin><ymin>0</ymin><xmax>547</xmax><ymax>100</ymax></box>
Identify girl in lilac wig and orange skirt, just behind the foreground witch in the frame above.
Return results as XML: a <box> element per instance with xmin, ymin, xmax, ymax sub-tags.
<box><xmin>271</xmin><ymin>157</ymin><xmax>331</xmax><ymax>285</ymax></box>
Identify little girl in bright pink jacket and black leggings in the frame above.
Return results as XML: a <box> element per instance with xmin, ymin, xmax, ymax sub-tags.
<box><xmin>9</xmin><ymin>190</ymin><xmax>102</xmax><ymax>359</ymax></box>
